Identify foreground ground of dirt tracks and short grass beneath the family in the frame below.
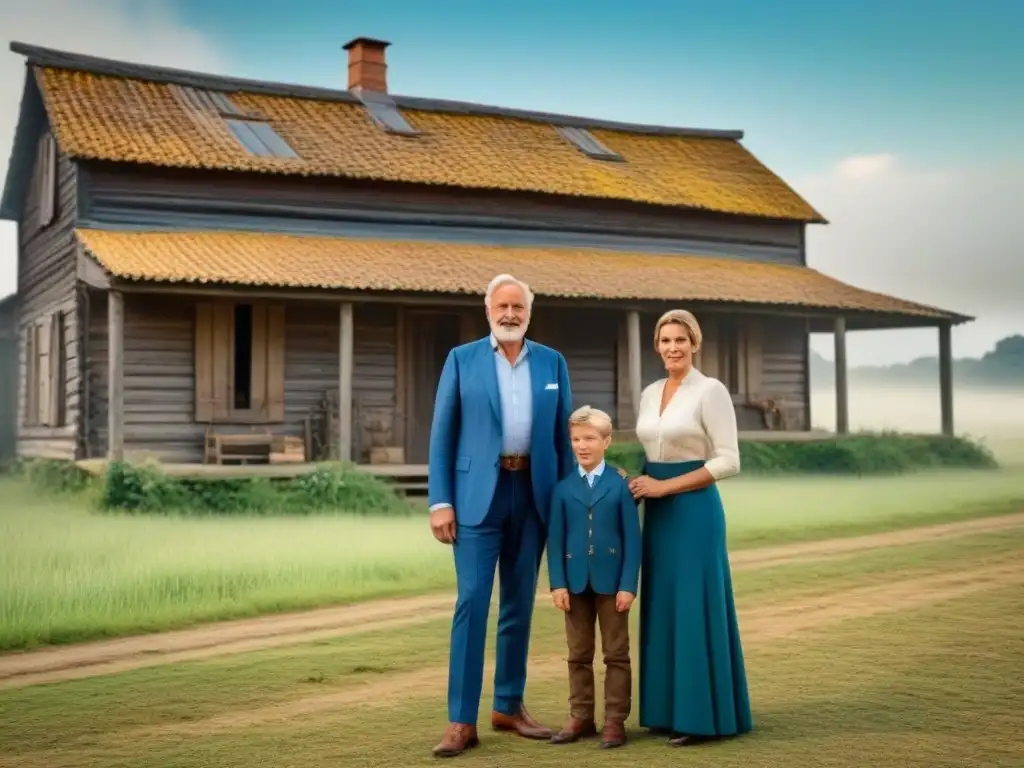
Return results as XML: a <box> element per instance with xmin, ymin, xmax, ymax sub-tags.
<box><xmin>0</xmin><ymin>528</ymin><xmax>1024</xmax><ymax>768</ymax></box>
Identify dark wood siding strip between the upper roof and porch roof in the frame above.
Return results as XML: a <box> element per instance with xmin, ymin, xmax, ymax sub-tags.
<box><xmin>82</xmin><ymin>163</ymin><xmax>804</xmax><ymax>264</ymax></box>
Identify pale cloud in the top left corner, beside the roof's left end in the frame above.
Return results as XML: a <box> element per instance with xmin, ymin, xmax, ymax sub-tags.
<box><xmin>0</xmin><ymin>0</ymin><xmax>224</xmax><ymax>296</ymax></box>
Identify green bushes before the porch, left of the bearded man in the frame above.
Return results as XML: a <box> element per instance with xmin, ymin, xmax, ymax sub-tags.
<box><xmin>100</xmin><ymin>463</ymin><xmax>413</xmax><ymax>516</ymax></box>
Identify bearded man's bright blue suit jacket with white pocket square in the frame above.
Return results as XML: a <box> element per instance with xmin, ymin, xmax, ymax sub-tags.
<box><xmin>427</xmin><ymin>336</ymin><xmax>575</xmax><ymax>525</ymax></box>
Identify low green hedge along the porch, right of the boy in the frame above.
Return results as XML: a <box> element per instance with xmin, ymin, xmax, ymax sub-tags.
<box><xmin>608</xmin><ymin>432</ymin><xmax>998</xmax><ymax>475</ymax></box>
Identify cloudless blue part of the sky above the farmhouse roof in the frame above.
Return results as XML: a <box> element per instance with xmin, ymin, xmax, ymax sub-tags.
<box><xmin>179</xmin><ymin>0</ymin><xmax>1024</xmax><ymax>174</ymax></box>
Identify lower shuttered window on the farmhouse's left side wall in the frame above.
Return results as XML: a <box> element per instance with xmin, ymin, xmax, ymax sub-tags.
<box><xmin>23</xmin><ymin>312</ymin><xmax>66</xmax><ymax>427</ymax></box>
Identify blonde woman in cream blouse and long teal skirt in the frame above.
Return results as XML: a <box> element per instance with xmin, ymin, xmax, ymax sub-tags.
<box><xmin>630</xmin><ymin>309</ymin><xmax>753</xmax><ymax>746</ymax></box>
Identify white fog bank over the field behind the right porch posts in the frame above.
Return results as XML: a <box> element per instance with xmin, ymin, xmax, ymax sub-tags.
<box><xmin>811</xmin><ymin>382</ymin><xmax>1024</xmax><ymax>463</ymax></box>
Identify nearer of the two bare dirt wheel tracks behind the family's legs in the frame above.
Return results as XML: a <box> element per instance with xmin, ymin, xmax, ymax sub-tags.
<box><xmin>132</xmin><ymin>561</ymin><xmax>1024</xmax><ymax>739</ymax></box>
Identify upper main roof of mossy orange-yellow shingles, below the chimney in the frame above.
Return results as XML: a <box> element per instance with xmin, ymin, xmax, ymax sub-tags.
<box><xmin>4</xmin><ymin>43</ymin><xmax>824</xmax><ymax>222</ymax></box>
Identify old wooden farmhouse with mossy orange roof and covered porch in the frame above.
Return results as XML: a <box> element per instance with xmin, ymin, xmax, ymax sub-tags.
<box><xmin>2</xmin><ymin>38</ymin><xmax>970</xmax><ymax>475</ymax></box>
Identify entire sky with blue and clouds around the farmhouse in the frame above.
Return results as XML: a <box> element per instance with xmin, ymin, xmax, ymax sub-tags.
<box><xmin>0</xmin><ymin>0</ymin><xmax>1024</xmax><ymax>365</ymax></box>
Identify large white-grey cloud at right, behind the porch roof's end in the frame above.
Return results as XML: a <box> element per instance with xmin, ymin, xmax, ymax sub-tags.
<box><xmin>796</xmin><ymin>155</ymin><xmax>1024</xmax><ymax>365</ymax></box>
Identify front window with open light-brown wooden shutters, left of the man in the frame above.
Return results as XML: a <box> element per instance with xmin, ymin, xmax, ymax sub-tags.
<box><xmin>196</xmin><ymin>301</ymin><xmax>285</xmax><ymax>424</ymax></box>
